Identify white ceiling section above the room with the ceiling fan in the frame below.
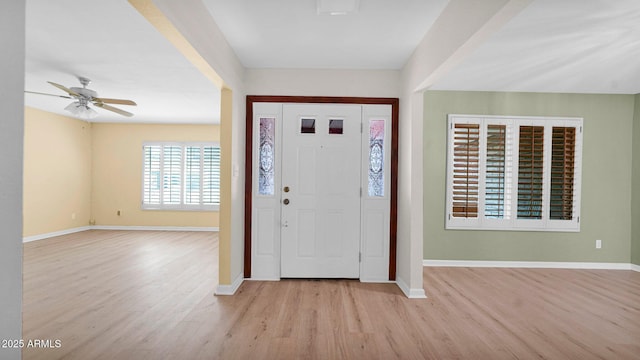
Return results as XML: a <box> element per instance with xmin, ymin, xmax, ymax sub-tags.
<box><xmin>25</xmin><ymin>0</ymin><xmax>220</xmax><ymax>124</ymax></box>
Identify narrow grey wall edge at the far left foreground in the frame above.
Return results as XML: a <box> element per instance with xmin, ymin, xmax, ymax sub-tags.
<box><xmin>0</xmin><ymin>0</ymin><xmax>26</xmax><ymax>360</ymax></box>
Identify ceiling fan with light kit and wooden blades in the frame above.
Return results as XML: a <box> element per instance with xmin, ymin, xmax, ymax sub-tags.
<box><xmin>25</xmin><ymin>76</ymin><xmax>137</xmax><ymax>119</ymax></box>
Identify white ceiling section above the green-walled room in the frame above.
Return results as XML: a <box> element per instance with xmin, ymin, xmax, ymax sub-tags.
<box><xmin>432</xmin><ymin>0</ymin><xmax>640</xmax><ymax>94</ymax></box>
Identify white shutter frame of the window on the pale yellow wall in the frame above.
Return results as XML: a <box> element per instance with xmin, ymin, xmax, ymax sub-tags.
<box><xmin>140</xmin><ymin>141</ymin><xmax>220</xmax><ymax>211</ymax></box>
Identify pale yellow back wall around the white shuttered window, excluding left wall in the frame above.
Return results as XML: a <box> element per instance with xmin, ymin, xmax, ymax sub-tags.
<box><xmin>91</xmin><ymin>123</ymin><xmax>219</xmax><ymax>227</ymax></box>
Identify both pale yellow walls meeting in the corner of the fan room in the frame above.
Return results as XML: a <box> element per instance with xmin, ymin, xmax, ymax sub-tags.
<box><xmin>23</xmin><ymin>108</ymin><xmax>219</xmax><ymax>237</ymax></box>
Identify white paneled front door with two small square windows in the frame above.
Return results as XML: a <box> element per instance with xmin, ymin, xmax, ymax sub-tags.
<box><xmin>281</xmin><ymin>104</ymin><xmax>362</xmax><ymax>278</ymax></box>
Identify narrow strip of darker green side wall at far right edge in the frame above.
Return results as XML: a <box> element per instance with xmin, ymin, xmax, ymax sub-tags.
<box><xmin>631</xmin><ymin>94</ymin><xmax>640</xmax><ymax>265</ymax></box>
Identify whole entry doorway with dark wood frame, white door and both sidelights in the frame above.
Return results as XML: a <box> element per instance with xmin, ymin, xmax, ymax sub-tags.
<box><xmin>245</xmin><ymin>96</ymin><xmax>397</xmax><ymax>281</ymax></box>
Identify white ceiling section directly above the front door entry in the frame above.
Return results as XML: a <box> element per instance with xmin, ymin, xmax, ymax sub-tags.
<box><xmin>203</xmin><ymin>0</ymin><xmax>447</xmax><ymax>69</ymax></box>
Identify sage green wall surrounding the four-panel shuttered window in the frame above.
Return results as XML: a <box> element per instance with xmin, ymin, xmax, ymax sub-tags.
<box><xmin>423</xmin><ymin>91</ymin><xmax>640</xmax><ymax>263</ymax></box>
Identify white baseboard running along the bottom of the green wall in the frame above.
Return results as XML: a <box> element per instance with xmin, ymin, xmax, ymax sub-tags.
<box><xmin>422</xmin><ymin>260</ymin><xmax>640</xmax><ymax>270</ymax></box>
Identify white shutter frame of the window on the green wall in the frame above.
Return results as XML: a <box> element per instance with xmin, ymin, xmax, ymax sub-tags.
<box><xmin>445</xmin><ymin>114</ymin><xmax>584</xmax><ymax>232</ymax></box>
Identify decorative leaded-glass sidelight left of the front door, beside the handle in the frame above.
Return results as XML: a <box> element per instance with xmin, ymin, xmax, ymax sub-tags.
<box><xmin>258</xmin><ymin>118</ymin><xmax>276</xmax><ymax>195</ymax></box>
